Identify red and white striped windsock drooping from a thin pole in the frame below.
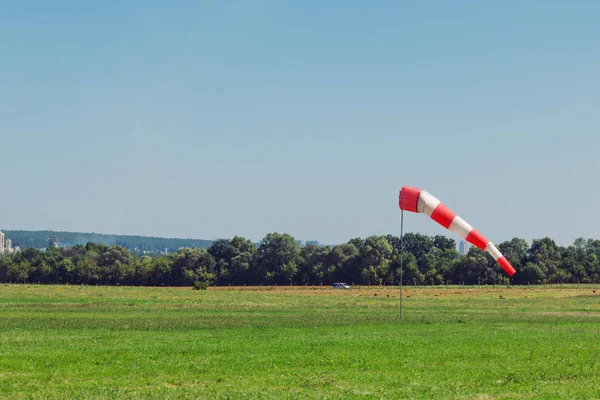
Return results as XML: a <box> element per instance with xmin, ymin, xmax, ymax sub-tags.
<box><xmin>399</xmin><ymin>186</ymin><xmax>517</xmax><ymax>276</ymax></box>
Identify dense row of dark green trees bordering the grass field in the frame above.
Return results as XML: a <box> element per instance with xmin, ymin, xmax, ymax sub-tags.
<box><xmin>0</xmin><ymin>233</ymin><xmax>600</xmax><ymax>286</ymax></box>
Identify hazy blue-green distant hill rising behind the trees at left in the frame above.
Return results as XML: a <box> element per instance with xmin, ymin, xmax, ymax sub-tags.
<box><xmin>2</xmin><ymin>230</ymin><xmax>212</xmax><ymax>254</ymax></box>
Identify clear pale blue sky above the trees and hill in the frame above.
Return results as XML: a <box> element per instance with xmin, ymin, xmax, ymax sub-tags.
<box><xmin>0</xmin><ymin>0</ymin><xmax>600</xmax><ymax>245</ymax></box>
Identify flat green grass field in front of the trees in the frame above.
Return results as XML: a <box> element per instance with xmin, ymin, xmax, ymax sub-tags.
<box><xmin>0</xmin><ymin>285</ymin><xmax>600</xmax><ymax>399</ymax></box>
